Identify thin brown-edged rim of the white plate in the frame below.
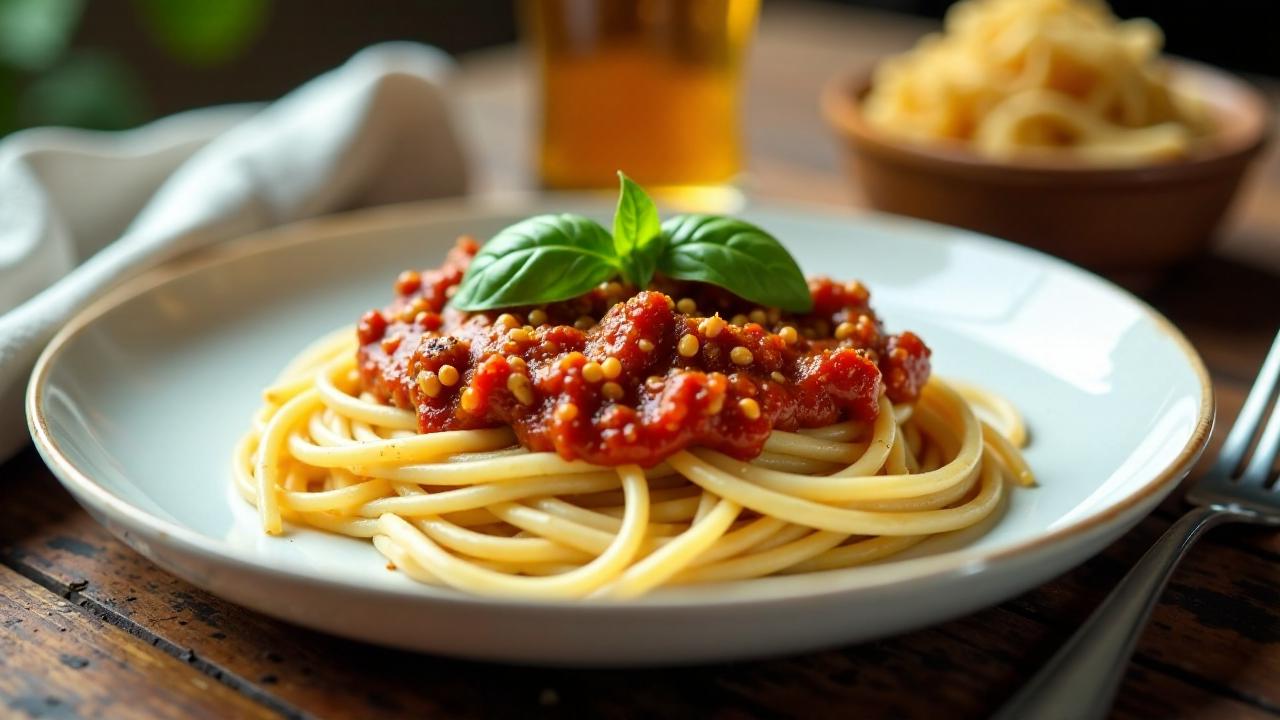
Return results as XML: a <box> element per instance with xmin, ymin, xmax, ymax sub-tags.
<box><xmin>26</xmin><ymin>192</ymin><xmax>1216</xmax><ymax>611</ymax></box>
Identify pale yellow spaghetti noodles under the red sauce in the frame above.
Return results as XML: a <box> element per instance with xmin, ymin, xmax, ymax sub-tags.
<box><xmin>234</xmin><ymin>328</ymin><xmax>1032</xmax><ymax>598</ymax></box>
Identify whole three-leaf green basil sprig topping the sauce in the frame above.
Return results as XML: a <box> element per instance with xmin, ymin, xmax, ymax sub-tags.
<box><xmin>451</xmin><ymin>172</ymin><xmax>813</xmax><ymax>313</ymax></box>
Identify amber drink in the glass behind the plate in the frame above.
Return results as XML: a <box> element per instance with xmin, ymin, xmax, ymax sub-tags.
<box><xmin>524</xmin><ymin>0</ymin><xmax>759</xmax><ymax>188</ymax></box>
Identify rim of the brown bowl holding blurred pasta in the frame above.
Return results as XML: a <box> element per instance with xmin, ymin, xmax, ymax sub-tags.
<box><xmin>819</xmin><ymin>55</ymin><xmax>1275</xmax><ymax>184</ymax></box>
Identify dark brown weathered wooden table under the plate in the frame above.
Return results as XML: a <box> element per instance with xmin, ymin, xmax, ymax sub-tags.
<box><xmin>0</xmin><ymin>5</ymin><xmax>1280</xmax><ymax>717</ymax></box>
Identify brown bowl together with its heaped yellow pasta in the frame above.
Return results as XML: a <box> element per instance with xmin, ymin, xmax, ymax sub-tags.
<box><xmin>823</xmin><ymin>0</ymin><xmax>1268</xmax><ymax>273</ymax></box>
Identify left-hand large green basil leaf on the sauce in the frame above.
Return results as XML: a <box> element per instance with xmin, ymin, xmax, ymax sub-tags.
<box><xmin>451</xmin><ymin>214</ymin><xmax>621</xmax><ymax>310</ymax></box>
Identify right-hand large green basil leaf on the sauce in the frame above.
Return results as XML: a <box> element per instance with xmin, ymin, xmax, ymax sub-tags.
<box><xmin>658</xmin><ymin>215</ymin><xmax>813</xmax><ymax>313</ymax></box>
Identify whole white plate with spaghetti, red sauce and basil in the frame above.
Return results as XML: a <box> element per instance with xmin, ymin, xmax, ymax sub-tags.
<box><xmin>28</xmin><ymin>176</ymin><xmax>1212</xmax><ymax>665</ymax></box>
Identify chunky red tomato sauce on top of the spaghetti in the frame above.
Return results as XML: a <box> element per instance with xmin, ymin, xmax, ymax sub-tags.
<box><xmin>357</xmin><ymin>237</ymin><xmax>931</xmax><ymax>466</ymax></box>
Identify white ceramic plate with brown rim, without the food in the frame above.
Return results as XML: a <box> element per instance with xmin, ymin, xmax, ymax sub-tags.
<box><xmin>28</xmin><ymin>197</ymin><xmax>1213</xmax><ymax>665</ymax></box>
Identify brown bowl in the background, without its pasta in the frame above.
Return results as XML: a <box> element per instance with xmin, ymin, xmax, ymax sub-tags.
<box><xmin>822</xmin><ymin>60</ymin><xmax>1270</xmax><ymax>274</ymax></box>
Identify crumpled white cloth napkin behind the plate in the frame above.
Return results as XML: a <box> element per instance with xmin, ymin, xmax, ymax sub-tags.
<box><xmin>0</xmin><ymin>42</ymin><xmax>466</xmax><ymax>459</ymax></box>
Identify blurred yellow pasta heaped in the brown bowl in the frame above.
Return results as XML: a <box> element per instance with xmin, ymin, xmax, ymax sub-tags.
<box><xmin>863</xmin><ymin>0</ymin><xmax>1213</xmax><ymax>165</ymax></box>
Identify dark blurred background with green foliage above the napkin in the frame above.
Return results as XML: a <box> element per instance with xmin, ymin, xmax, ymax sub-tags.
<box><xmin>0</xmin><ymin>0</ymin><xmax>515</xmax><ymax>136</ymax></box>
